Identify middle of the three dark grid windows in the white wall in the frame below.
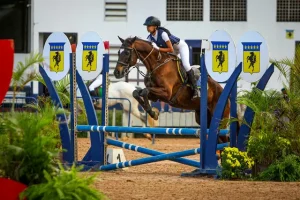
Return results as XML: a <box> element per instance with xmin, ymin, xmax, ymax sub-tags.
<box><xmin>210</xmin><ymin>0</ymin><xmax>247</xmax><ymax>21</ymax></box>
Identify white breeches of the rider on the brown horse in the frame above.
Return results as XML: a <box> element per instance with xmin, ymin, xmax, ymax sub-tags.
<box><xmin>173</xmin><ymin>40</ymin><xmax>191</xmax><ymax>71</ymax></box>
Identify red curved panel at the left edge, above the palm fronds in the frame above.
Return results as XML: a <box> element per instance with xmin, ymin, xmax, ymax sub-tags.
<box><xmin>0</xmin><ymin>40</ymin><xmax>15</xmax><ymax>104</ymax></box>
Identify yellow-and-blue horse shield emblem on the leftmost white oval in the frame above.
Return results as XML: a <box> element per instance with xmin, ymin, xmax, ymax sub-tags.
<box><xmin>49</xmin><ymin>42</ymin><xmax>65</xmax><ymax>73</ymax></box>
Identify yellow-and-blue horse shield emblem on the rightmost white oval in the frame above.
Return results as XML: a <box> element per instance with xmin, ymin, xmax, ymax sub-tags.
<box><xmin>242</xmin><ymin>42</ymin><xmax>261</xmax><ymax>74</ymax></box>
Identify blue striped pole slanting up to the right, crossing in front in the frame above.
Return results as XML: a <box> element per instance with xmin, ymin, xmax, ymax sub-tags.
<box><xmin>99</xmin><ymin>148</ymin><xmax>201</xmax><ymax>171</ymax></box>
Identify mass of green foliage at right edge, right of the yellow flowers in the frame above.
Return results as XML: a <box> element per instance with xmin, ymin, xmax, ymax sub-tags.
<box><xmin>230</xmin><ymin>47</ymin><xmax>300</xmax><ymax>181</ymax></box>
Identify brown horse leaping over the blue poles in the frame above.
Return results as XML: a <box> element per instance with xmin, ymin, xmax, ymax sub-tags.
<box><xmin>114</xmin><ymin>36</ymin><xmax>230</xmax><ymax>145</ymax></box>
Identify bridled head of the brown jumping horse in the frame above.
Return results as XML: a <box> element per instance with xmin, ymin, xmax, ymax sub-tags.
<box><xmin>114</xmin><ymin>36</ymin><xmax>138</xmax><ymax>78</ymax></box>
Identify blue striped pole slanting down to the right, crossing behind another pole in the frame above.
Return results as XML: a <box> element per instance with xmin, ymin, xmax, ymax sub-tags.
<box><xmin>106</xmin><ymin>139</ymin><xmax>200</xmax><ymax>168</ymax></box>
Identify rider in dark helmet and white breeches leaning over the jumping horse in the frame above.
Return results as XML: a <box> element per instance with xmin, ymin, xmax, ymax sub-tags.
<box><xmin>144</xmin><ymin>16</ymin><xmax>200</xmax><ymax>98</ymax></box>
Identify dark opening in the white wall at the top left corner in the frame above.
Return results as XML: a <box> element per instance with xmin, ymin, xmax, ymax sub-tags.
<box><xmin>0</xmin><ymin>0</ymin><xmax>30</xmax><ymax>53</ymax></box>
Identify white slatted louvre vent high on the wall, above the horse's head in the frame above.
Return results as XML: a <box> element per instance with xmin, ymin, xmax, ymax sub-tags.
<box><xmin>105</xmin><ymin>0</ymin><xmax>127</xmax><ymax>21</ymax></box>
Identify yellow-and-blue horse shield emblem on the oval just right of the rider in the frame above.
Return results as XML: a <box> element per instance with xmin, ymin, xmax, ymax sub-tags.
<box><xmin>211</xmin><ymin>41</ymin><xmax>229</xmax><ymax>74</ymax></box>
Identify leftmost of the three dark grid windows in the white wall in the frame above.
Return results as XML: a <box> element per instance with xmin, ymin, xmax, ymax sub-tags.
<box><xmin>167</xmin><ymin>0</ymin><xmax>203</xmax><ymax>21</ymax></box>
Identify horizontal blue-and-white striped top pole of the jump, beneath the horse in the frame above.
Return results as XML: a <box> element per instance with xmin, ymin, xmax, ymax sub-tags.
<box><xmin>77</xmin><ymin>125</ymin><xmax>228</xmax><ymax>136</ymax></box>
